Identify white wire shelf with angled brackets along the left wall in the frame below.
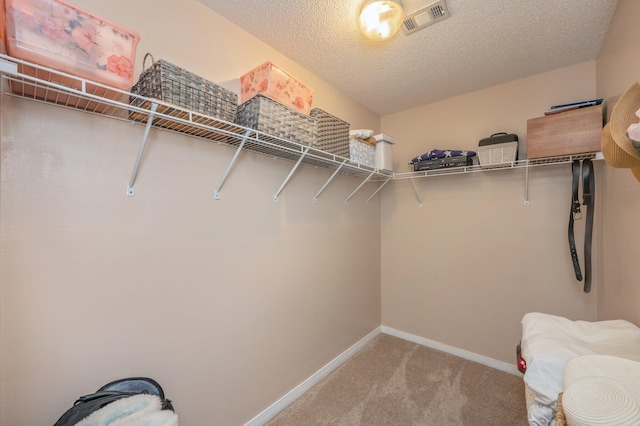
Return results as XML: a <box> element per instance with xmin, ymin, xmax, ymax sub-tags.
<box><xmin>0</xmin><ymin>55</ymin><xmax>393</xmax><ymax>202</ymax></box>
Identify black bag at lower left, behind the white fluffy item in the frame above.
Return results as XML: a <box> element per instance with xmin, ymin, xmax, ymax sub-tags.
<box><xmin>53</xmin><ymin>377</ymin><xmax>175</xmax><ymax>426</ymax></box>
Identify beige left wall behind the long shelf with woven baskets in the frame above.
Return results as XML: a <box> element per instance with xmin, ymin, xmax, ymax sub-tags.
<box><xmin>0</xmin><ymin>0</ymin><xmax>381</xmax><ymax>426</ymax></box>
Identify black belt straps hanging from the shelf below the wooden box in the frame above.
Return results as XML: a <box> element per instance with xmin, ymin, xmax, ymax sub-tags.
<box><xmin>569</xmin><ymin>159</ymin><xmax>595</xmax><ymax>293</ymax></box>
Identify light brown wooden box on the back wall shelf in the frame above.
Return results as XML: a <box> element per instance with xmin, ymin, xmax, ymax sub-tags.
<box><xmin>527</xmin><ymin>105</ymin><xmax>602</xmax><ymax>158</ymax></box>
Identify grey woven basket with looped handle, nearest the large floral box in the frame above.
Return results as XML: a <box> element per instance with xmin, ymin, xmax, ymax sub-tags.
<box><xmin>129</xmin><ymin>53</ymin><xmax>238</xmax><ymax>123</ymax></box>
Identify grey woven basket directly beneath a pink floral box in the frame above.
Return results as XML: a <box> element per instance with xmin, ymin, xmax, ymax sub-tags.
<box><xmin>236</xmin><ymin>94</ymin><xmax>317</xmax><ymax>146</ymax></box>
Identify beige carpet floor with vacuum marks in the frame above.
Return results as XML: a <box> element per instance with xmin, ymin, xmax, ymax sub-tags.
<box><xmin>267</xmin><ymin>334</ymin><xmax>528</xmax><ymax>426</ymax></box>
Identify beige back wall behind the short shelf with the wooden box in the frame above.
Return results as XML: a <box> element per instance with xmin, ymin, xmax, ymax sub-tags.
<box><xmin>382</xmin><ymin>61</ymin><xmax>603</xmax><ymax>363</ymax></box>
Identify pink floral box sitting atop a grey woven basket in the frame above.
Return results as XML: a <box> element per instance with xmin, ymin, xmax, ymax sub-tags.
<box><xmin>240</xmin><ymin>62</ymin><xmax>314</xmax><ymax>114</ymax></box>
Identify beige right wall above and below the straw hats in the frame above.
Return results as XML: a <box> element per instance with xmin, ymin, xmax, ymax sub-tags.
<box><xmin>597</xmin><ymin>0</ymin><xmax>640</xmax><ymax>324</ymax></box>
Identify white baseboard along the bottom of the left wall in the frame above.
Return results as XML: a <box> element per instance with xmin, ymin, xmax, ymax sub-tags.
<box><xmin>245</xmin><ymin>327</ymin><xmax>381</xmax><ymax>426</ymax></box>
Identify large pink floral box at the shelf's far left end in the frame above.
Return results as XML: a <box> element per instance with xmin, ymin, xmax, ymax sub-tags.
<box><xmin>5</xmin><ymin>0</ymin><xmax>140</xmax><ymax>90</ymax></box>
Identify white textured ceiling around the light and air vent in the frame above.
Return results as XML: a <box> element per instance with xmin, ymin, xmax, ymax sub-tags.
<box><xmin>199</xmin><ymin>0</ymin><xmax>618</xmax><ymax>115</ymax></box>
